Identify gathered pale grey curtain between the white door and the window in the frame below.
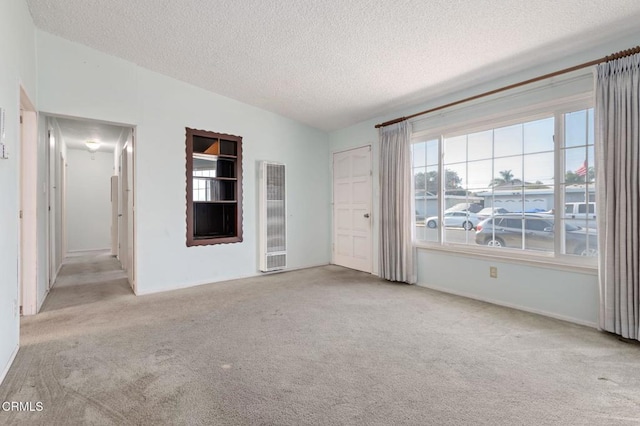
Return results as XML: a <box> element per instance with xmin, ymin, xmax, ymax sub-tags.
<box><xmin>379</xmin><ymin>122</ymin><xmax>416</xmax><ymax>284</ymax></box>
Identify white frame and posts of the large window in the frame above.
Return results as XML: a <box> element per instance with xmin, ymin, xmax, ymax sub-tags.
<box><xmin>410</xmin><ymin>96</ymin><xmax>598</xmax><ymax>272</ymax></box>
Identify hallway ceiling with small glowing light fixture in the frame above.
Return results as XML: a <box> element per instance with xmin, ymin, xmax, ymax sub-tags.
<box><xmin>53</xmin><ymin>117</ymin><xmax>130</xmax><ymax>152</ymax></box>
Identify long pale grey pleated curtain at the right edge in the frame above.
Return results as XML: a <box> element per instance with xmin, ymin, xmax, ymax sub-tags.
<box><xmin>595</xmin><ymin>54</ymin><xmax>640</xmax><ymax>340</ymax></box>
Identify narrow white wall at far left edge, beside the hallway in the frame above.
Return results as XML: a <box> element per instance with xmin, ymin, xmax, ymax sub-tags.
<box><xmin>0</xmin><ymin>0</ymin><xmax>37</xmax><ymax>381</ymax></box>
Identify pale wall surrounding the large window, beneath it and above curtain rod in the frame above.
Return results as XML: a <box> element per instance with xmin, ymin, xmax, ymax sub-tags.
<box><xmin>329</xmin><ymin>34</ymin><xmax>640</xmax><ymax>326</ymax></box>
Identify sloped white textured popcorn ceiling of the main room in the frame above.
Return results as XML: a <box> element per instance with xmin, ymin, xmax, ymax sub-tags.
<box><xmin>28</xmin><ymin>0</ymin><xmax>640</xmax><ymax>130</ymax></box>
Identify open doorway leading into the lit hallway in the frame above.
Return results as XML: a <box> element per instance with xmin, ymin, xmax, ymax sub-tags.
<box><xmin>48</xmin><ymin>115</ymin><xmax>135</xmax><ymax>291</ymax></box>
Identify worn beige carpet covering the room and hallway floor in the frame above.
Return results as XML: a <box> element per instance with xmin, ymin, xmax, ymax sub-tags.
<box><xmin>0</xmin><ymin>251</ymin><xmax>640</xmax><ymax>425</ymax></box>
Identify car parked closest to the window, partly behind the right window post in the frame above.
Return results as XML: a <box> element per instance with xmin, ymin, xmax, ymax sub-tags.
<box><xmin>476</xmin><ymin>213</ymin><xmax>598</xmax><ymax>256</ymax></box>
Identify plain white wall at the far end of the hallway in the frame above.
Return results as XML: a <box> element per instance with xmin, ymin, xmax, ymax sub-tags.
<box><xmin>67</xmin><ymin>149</ymin><xmax>113</xmax><ymax>252</ymax></box>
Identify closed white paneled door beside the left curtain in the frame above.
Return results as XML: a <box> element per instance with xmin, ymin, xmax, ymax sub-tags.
<box><xmin>333</xmin><ymin>146</ymin><xmax>373</xmax><ymax>272</ymax></box>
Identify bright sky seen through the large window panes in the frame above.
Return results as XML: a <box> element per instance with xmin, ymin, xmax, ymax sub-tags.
<box><xmin>413</xmin><ymin>109</ymin><xmax>594</xmax><ymax>196</ymax></box>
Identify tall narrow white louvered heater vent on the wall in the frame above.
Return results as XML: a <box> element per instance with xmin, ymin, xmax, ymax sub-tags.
<box><xmin>259</xmin><ymin>161</ymin><xmax>287</xmax><ymax>272</ymax></box>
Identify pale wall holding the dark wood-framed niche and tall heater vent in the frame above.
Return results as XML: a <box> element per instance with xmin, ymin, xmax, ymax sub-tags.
<box><xmin>37</xmin><ymin>31</ymin><xmax>330</xmax><ymax>293</ymax></box>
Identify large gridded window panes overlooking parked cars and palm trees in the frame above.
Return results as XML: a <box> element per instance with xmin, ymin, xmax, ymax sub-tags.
<box><xmin>412</xmin><ymin>108</ymin><xmax>597</xmax><ymax>258</ymax></box>
